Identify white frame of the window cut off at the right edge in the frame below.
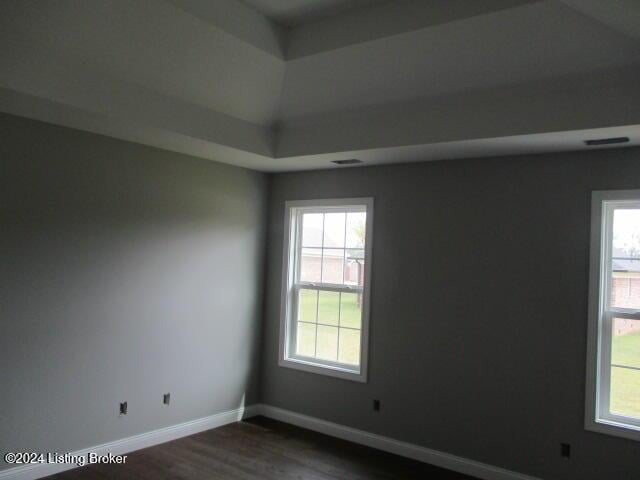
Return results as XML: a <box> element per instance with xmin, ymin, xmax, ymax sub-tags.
<box><xmin>585</xmin><ymin>190</ymin><xmax>640</xmax><ymax>440</ymax></box>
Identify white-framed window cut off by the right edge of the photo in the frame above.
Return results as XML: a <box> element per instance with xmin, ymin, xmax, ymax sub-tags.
<box><xmin>586</xmin><ymin>190</ymin><xmax>640</xmax><ymax>440</ymax></box>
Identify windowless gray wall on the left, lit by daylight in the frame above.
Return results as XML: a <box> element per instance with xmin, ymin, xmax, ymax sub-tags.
<box><xmin>0</xmin><ymin>115</ymin><xmax>267</xmax><ymax>469</ymax></box>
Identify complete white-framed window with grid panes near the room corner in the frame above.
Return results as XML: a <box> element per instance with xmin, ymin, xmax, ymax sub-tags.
<box><xmin>280</xmin><ymin>198</ymin><xmax>373</xmax><ymax>382</ymax></box>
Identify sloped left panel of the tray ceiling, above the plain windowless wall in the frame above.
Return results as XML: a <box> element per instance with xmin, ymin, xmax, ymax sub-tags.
<box><xmin>0</xmin><ymin>0</ymin><xmax>285</xmax><ymax>125</ymax></box>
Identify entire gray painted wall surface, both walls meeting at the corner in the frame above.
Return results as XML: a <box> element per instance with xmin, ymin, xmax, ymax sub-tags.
<box><xmin>0</xmin><ymin>108</ymin><xmax>640</xmax><ymax>480</ymax></box>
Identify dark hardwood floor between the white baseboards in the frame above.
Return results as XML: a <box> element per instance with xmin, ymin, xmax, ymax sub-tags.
<box><xmin>49</xmin><ymin>417</ymin><xmax>471</xmax><ymax>480</ymax></box>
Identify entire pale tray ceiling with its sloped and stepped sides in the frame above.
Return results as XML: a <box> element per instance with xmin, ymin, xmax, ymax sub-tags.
<box><xmin>0</xmin><ymin>0</ymin><xmax>640</xmax><ymax>171</ymax></box>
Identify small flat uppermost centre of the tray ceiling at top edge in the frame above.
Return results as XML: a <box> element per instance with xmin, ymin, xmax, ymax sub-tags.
<box><xmin>243</xmin><ymin>0</ymin><xmax>390</xmax><ymax>27</ymax></box>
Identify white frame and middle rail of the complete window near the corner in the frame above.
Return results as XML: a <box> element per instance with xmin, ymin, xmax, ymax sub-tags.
<box><xmin>278</xmin><ymin>198</ymin><xmax>373</xmax><ymax>383</ymax></box>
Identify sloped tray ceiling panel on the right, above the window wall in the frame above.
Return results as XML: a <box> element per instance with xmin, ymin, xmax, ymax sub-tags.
<box><xmin>280</xmin><ymin>1</ymin><xmax>640</xmax><ymax>120</ymax></box>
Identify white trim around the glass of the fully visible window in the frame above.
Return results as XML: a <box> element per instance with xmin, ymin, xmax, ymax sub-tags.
<box><xmin>278</xmin><ymin>198</ymin><xmax>373</xmax><ymax>383</ymax></box>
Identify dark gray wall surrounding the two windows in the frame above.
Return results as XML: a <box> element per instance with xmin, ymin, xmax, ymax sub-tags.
<box><xmin>262</xmin><ymin>149</ymin><xmax>640</xmax><ymax>480</ymax></box>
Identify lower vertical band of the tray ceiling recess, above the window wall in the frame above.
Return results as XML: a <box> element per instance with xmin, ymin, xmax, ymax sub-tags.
<box><xmin>276</xmin><ymin>68</ymin><xmax>640</xmax><ymax>158</ymax></box>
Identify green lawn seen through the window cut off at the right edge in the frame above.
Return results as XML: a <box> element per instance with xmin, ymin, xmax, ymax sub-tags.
<box><xmin>611</xmin><ymin>332</ymin><xmax>640</xmax><ymax>418</ymax></box>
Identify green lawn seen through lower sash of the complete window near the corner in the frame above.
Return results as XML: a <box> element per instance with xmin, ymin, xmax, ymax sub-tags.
<box><xmin>296</xmin><ymin>289</ymin><xmax>362</xmax><ymax>365</ymax></box>
